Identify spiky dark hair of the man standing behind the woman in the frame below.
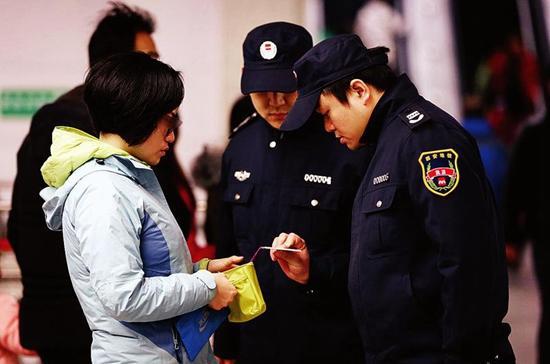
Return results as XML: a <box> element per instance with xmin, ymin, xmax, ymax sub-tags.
<box><xmin>88</xmin><ymin>2</ymin><xmax>155</xmax><ymax>67</ymax></box>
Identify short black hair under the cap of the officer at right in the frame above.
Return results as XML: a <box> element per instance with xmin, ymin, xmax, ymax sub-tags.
<box><xmin>323</xmin><ymin>64</ymin><xmax>397</xmax><ymax>105</ymax></box>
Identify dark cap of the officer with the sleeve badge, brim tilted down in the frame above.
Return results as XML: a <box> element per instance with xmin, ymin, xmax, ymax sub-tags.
<box><xmin>281</xmin><ymin>34</ymin><xmax>388</xmax><ymax>130</ymax></box>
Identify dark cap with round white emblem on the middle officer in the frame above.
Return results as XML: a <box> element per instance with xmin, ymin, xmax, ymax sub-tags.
<box><xmin>241</xmin><ymin>22</ymin><xmax>313</xmax><ymax>95</ymax></box>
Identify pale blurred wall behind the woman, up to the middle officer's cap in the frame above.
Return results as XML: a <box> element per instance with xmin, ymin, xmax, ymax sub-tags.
<box><xmin>0</xmin><ymin>0</ymin><xmax>320</xmax><ymax>181</ymax></box>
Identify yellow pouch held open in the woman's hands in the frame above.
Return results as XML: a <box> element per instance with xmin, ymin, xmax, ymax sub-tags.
<box><xmin>223</xmin><ymin>262</ymin><xmax>266</xmax><ymax>322</ymax></box>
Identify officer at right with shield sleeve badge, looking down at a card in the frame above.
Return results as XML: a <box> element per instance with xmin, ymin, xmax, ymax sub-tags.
<box><xmin>272</xmin><ymin>35</ymin><xmax>515</xmax><ymax>364</ymax></box>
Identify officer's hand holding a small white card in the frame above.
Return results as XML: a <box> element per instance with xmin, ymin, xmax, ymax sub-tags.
<box><xmin>269</xmin><ymin>233</ymin><xmax>309</xmax><ymax>284</ymax></box>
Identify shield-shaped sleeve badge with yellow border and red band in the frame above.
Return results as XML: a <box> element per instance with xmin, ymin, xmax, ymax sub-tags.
<box><xmin>418</xmin><ymin>149</ymin><xmax>460</xmax><ymax>196</ymax></box>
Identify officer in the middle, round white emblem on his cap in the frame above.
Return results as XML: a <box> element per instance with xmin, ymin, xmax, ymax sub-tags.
<box><xmin>214</xmin><ymin>22</ymin><xmax>365</xmax><ymax>364</ymax></box>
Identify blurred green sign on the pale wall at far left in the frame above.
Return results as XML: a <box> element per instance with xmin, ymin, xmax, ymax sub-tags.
<box><xmin>0</xmin><ymin>88</ymin><xmax>63</xmax><ymax>119</ymax></box>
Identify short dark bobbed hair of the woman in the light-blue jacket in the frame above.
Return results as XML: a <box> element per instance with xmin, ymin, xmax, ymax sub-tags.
<box><xmin>84</xmin><ymin>52</ymin><xmax>184</xmax><ymax>145</ymax></box>
